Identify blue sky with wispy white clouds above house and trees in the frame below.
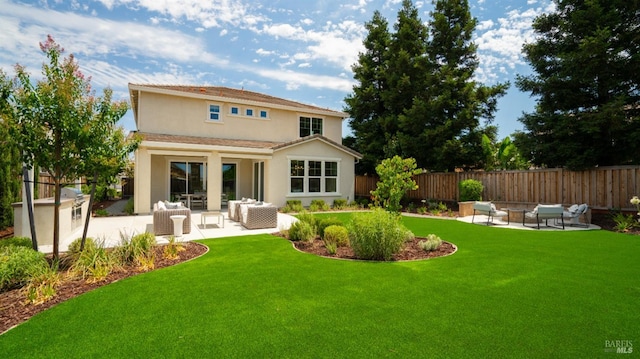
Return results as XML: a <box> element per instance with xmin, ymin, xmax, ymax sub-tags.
<box><xmin>0</xmin><ymin>0</ymin><xmax>553</xmax><ymax>138</ymax></box>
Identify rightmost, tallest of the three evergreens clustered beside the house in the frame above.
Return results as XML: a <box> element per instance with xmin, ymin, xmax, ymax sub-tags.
<box><xmin>401</xmin><ymin>0</ymin><xmax>509</xmax><ymax>171</ymax></box>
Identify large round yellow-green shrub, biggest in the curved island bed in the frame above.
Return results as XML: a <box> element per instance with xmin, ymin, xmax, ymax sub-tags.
<box><xmin>348</xmin><ymin>208</ymin><xmax>413</xmax><ymax>261</ymax></box>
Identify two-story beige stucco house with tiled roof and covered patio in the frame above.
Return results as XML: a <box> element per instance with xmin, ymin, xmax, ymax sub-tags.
<box><xmin>129</xmin><ymin>84</ymin><xmax>361</xmax><ymax>213</ymax></box>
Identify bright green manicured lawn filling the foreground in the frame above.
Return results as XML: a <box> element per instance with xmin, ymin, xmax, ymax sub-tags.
<box><xmin>0</xmin><ymin>213</ymin><xmax>640</xmax><ymax>358</ymax></box>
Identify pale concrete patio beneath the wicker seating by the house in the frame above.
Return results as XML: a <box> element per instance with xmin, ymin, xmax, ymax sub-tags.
<box><xmin>38</xmin><ymin>201</ymin><xmax>297</xmax><ymax>253</ymax></box>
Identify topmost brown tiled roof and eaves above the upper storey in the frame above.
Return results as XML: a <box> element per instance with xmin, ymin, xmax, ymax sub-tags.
<box><xmin>129</xmin><ymin>83</ymin><xmax>349</xmax><ymax>119</ymax></box>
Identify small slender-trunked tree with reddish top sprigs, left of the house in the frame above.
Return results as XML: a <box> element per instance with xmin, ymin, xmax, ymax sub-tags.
<box><xmin>2</xmin><ymin>36</ymin><xmax>136</xmax><ymax>258</ymax></box>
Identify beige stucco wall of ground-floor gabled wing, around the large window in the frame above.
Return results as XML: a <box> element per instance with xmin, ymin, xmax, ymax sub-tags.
<box><xmin>265</xmin><ymin>140</ymin><xmax>355</xmax><ymax>207</ymax></box>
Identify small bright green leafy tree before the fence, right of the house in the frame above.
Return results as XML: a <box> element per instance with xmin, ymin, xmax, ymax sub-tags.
<box><xmin>371</xmin><ymin>156</ymin><xmax>422</xmax><ymax>212</ymax></box>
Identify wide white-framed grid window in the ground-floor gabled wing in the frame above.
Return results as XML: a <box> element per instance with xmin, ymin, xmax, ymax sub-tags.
<box><xmin>289</xmin><ymin>158</ymin><xmax>339</xmax><ymax>195</ymax></box>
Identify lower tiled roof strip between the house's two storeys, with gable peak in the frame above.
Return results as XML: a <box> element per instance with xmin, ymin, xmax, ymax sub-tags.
<box><xmin>138</xmin><ymin>132</ymin><xmax>362</xmax><ymax>159</ymax></box>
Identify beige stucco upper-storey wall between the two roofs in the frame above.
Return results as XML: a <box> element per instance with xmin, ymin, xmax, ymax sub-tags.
<box><xmin>138</xmin><ymin>92</ymin><xmax>342</xmax><ymax>143</ymax></box>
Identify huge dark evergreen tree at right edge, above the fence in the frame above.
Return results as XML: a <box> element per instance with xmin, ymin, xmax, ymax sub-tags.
<box><xmin>516</xmin><ymin>0</ymin><xmax>640</xmax><ymax>169</ymax></box>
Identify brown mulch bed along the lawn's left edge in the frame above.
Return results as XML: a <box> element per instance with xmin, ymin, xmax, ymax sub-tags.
<box><xmin>0</xmin><ymin>242</ymin><xmax>208</xmax><ymax>333</ymax></box>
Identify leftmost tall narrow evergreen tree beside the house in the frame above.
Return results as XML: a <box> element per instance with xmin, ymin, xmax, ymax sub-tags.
<box><xmin>345</xmin><ymin>11</ymin><xmax>391</xmax><ymax>173</ymax></box>
